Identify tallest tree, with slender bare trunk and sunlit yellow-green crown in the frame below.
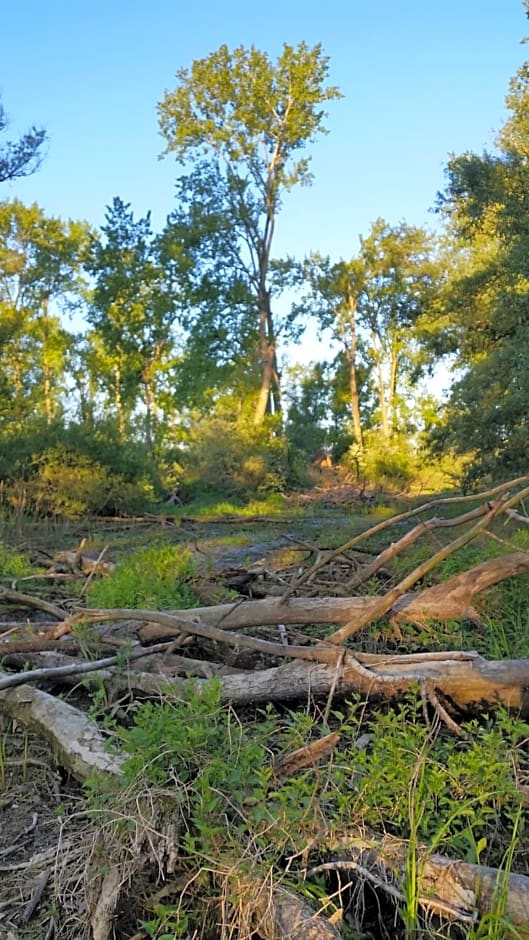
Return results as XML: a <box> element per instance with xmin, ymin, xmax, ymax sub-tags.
<box><xmin>159</xmin><ymin>42</ymin><xmax>339</xmax><ymax>424</ymax></box>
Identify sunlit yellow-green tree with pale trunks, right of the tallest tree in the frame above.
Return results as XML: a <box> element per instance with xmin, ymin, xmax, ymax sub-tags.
<box><xmin>302</xmin><ymin>219</ymin><xmax>435</xmax><ymax>449</ymax></box>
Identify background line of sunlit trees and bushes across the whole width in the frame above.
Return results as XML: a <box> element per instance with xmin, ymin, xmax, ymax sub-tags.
<box><xmin>0</xmin><ymin>27</ymin><xmax>529</xmax><ymax>516</ymax></box>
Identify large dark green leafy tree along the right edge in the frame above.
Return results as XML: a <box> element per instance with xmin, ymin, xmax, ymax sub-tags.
<box><xmin>437</xmin><ymin>57</ymin><xmax>529</xmax><ymax>481</ymax></box>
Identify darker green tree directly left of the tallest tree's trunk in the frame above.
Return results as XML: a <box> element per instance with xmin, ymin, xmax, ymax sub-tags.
<box><xmin>160</xmin><ymin>164</ymin><xmax>259</xmax><ymax>409</ymax></box>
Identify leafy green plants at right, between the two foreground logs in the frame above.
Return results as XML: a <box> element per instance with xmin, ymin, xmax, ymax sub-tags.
<box><xmin>336</xmin><ymin>702</ymin><xmax>529</xmax><ymax>865</ymax></box>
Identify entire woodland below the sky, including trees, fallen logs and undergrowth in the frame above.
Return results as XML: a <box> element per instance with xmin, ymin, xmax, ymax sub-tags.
<box><xmin>0</xmin><ymin>12</ymin><xmax>529</xmax><ymax>940</ymax></box>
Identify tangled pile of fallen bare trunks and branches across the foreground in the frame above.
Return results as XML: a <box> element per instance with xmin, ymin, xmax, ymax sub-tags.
<box><xmin>0</xmin><ymin>478</ymin><xmax>529</xmax><ymax>940</ymax></box>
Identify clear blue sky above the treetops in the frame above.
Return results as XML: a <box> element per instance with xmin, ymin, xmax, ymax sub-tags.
<box><xmin>0</xmin><ymin>0</ymin><xmax>529</xmax><ymax>258</ymax></box>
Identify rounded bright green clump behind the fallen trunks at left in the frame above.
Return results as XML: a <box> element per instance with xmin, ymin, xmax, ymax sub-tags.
<box><xmin>87</xmin><ymin>543</ymin><xmax>198</xmax><ymax>610</ymax></box>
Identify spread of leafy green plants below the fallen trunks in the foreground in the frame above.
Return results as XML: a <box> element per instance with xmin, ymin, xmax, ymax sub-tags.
<box><xmin>85</xmin><ymin>681</ymin><xmax>529</xmax><ymax>940</ymax></box>
